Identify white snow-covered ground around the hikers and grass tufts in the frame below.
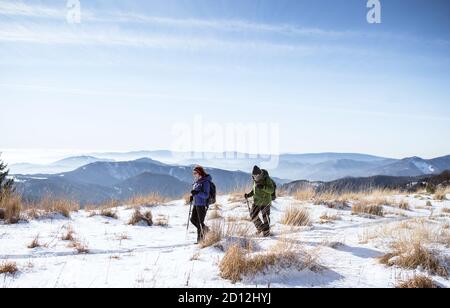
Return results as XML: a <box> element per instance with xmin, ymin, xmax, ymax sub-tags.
<box><xmin>0</xmin><ymin>196</ymin><xmax>450</xmax><ymax>288</ymax></box>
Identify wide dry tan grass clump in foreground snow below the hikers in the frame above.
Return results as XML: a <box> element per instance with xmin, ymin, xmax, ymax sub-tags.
<box><xmin>219</xmin><ymin>242</ymin><xmax>322</xmax><ymax>283</ymax></box>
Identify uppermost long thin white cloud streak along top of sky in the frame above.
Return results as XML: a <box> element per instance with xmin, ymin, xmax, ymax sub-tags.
<box><xmin>0</xmin><ymin>0</ymin><xmax>450</xmax><ymax>48</ymax></box>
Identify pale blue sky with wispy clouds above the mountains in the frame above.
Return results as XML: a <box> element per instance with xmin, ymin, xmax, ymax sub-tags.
<box><xmin>0</xmin><ymin>0</ymin><xmax>450</xmax><ymax>157</ymax></box>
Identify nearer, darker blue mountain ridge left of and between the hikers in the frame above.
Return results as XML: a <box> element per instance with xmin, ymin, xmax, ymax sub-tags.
<box><xmin>14</xmin><ymin>158</ymin><xmax>258</xmax><ymax>204</ymax></box>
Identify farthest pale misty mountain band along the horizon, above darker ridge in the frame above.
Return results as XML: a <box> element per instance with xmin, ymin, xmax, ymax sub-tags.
<box><xmin>10</xmin><ymin>151</ymin><xmax>450</xmax><ymax>181</ymax></box>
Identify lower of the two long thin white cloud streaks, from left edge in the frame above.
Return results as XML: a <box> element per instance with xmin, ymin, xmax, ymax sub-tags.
<box><xmin>0</xmin><ymin>23</ymin><xmax>365</xmax><ymax>56</ymax></box>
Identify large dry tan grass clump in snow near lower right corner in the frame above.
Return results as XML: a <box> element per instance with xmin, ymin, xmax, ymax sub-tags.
<box><xmin>380</xmin><ymin>241</ymin><xmax>448</xmax><ymax>277</ymax></box>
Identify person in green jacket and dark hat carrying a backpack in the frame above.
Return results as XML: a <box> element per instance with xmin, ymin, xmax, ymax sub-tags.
<box><xmin>245</xmin><ymin>166</ymin><xmax>275</xmax><ymax>237</ymax></box>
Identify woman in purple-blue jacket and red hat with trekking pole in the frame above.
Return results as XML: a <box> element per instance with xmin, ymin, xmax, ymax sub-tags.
<box><xmin>191</xmin><ymin>166</ymin><xmax>212</xmax><ymax>243</ymax></box>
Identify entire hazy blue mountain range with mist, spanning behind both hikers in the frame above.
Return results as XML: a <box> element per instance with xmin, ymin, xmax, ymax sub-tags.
<box><xmin>11</xmin><ymin>151</ymin><xmax>450</xmax><ymax>204</ymax></box>
